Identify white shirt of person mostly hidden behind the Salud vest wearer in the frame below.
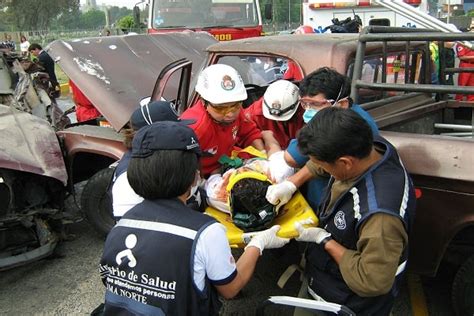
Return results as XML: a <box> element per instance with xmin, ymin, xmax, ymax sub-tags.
<box><xmin>112</xmin><ymin>171</ymin><xmax>143</xmax><ymax>217</ymax></box>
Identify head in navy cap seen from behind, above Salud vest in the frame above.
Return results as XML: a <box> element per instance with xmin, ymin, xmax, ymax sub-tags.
<box><xmin>127</xmin><ymin>121</ymin><xmax>201</xmax><ymax>200</ymax></box>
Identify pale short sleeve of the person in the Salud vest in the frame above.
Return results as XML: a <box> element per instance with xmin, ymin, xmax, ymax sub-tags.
<box><xmin>194</xmin><ymin>223</ymin><xmax>237</xmax><ymax>290</ymax></box>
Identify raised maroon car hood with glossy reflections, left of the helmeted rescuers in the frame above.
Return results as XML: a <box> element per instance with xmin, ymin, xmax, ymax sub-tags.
<box><xmin>46</xmin><ymin>31</ymin><xmax>217</xmax><ymax>130</ymax></box>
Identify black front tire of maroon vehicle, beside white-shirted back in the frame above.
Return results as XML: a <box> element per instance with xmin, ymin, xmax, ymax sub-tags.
<box><xmin>81</xmin><ymin>168</ymin><xmax>115</xmax><ymax>237</ymax></box>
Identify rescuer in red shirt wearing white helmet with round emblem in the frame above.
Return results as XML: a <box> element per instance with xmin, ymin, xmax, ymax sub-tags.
<box><xmin>181</xmin><ymin>64</ymin><xmax>264</xmax><ymax>178</ymax></box>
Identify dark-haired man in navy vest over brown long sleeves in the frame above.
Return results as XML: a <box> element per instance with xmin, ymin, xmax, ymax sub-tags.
<box><xmin>296</xmin><ymin>107</ymin><xmax>415</xmax><ymax>315</ymax></box>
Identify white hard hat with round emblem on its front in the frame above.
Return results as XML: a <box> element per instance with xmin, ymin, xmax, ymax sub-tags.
<box><xmin>196</xmin><ymin>64</ymin><xmax>247</xmax><ymax>104</ymax></box>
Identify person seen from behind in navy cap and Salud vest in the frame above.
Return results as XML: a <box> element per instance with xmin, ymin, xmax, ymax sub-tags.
<box><xmin>99</xmin><ymin>121</ymin><xmax>289</xmax><ymax>315</ymax></box>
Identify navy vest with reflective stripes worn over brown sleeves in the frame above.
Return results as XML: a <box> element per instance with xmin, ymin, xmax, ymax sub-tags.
<box><xmin>306</xmin><ymin>136</ymin><xmax>415</xmax><ymax>315</ymax></box>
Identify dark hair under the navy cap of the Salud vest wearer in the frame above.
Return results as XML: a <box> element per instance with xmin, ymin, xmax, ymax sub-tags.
<box><xmin>127</xmin><ymin>150</ymin><xmax>199</xmax><ymax>200</ymax></box>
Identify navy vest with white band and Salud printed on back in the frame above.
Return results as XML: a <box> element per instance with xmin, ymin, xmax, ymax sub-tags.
<box><xmin>99</xmin><ymin>199</ymin><xmax>220</xmax><ymax>315</ymax></box>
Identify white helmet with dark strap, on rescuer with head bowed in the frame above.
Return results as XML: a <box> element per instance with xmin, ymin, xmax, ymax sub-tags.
<box><xmin>262</xmin><ymin>80</ymin><xmax>299</xmax><ymax>121</ymax></box>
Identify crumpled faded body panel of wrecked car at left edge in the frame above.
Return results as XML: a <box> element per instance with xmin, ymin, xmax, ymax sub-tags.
<box><xmin>0</xmin><ymin>104</ymin><xmax>68</xmax><ymax>185</ymax></box>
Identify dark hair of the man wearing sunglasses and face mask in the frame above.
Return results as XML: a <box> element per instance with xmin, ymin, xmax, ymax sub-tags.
<box><xmin>299</xmin><ymin>67</ymin><xmax>351</xmax><ymax>104</ymax></box>
